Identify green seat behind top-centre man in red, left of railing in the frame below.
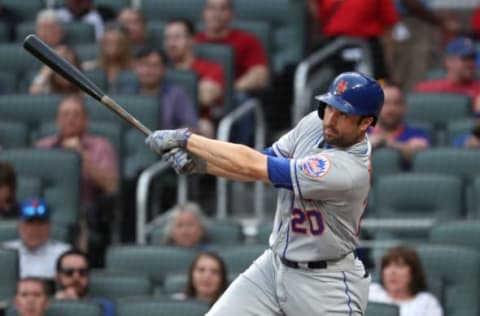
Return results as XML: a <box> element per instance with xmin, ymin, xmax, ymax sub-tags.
<box><xmin>234</xmin><ymin>0</ymin><xmax>307</xmax><ymax>73</ymax></box>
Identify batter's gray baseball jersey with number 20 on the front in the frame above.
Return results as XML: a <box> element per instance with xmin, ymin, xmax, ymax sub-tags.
<box><xmin>270</xmin><ymin>111</ymin><xmax>371</xmax><ymax>261</ymax></box>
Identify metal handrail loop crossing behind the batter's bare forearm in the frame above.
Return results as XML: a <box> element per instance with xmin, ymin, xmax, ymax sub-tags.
<box><xmin>216</xmin><ymin>98</ymin><xmax>266</xmax><ymax>219</ymax></box>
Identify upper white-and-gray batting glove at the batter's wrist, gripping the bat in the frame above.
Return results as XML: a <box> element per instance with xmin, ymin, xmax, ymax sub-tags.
<box><xmin>145</xmin><ymin>128</ymin><xmax>191</xmax><ymax>155</ymax></box>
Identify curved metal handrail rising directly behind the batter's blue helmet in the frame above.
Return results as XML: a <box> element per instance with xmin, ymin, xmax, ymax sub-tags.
<box><xmin>292</xmin><ymin>37</ymin><xmax>373</xmax><ymax>126</ymax></box>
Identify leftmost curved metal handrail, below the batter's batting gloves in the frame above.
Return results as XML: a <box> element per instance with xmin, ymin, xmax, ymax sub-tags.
<box><xmin>136</xmin><ymin>161</ymin><xmax>188</xmax><ymax>245</ymax></box>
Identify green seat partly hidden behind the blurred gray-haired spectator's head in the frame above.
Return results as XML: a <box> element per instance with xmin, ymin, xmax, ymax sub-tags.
<box><xmin>150</xmin><ymin>221</ymin><xmax>243</xmax><ymax>245</ymax></box>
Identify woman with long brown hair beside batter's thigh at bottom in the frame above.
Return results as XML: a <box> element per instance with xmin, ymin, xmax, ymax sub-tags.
<box><xmin>173</xmin><ymin>252</ymin><xmax>228</xmax><ymax>305</ymax></box>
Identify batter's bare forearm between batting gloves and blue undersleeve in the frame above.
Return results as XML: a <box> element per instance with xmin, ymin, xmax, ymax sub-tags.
<box><xmin>187</xmin><ymin>134</ymin><xmax>269</xmax><ymax>182</ymax></box>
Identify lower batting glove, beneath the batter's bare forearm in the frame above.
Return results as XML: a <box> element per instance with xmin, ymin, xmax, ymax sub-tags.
<box><xmin>162</xmin><ymin>147</ymin><xmax>207</xmax><ymax>174</ymax></box>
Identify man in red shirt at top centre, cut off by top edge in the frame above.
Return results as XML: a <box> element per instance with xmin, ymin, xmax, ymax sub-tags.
<box><xmin>196</xmin><ymin>0</ymin><xmax>270</xmax><ymax>93</ymax></box>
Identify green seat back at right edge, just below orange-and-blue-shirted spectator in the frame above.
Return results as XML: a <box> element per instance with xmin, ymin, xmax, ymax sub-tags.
<box><xmin>412</xmin><ymin>148</ymin><xmax>480</xmax><ymax>183</ymax></box>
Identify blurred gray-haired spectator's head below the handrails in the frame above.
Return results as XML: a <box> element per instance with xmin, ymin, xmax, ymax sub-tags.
<box><xmin>163</xmin><ymin>203</ymin><xmax>206</xmax><ymax>248</ymax></box>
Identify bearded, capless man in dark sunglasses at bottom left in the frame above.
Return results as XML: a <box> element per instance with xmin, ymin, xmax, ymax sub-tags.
<box><xmin>55</xmin><ymin>249</ymin><xmax>115</xmax><ymax>316</ymax></box>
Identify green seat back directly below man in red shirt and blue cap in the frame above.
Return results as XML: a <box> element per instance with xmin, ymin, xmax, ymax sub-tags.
<box><xmin>406</xmin><ymin>93</ymin><xmax>472</xmax><ymax>129</ymax></box>
